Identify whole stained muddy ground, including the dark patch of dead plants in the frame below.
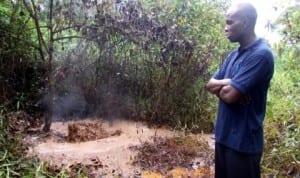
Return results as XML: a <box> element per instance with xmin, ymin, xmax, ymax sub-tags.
<box><xmin>19</xmin><ymin>115</ymin><xmax>213</xmax><ymax>177</ymax></box>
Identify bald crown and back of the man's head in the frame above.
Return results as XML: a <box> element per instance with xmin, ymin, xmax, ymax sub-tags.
<box><xmin>227</xmin><ymin>2</ymin><xmax>257</xmax><ymax>30</ymax></box>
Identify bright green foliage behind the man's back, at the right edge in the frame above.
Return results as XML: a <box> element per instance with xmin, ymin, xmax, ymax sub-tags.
<box><xmin>263</xmin><ymin>5</ymin><xmax>300</xmax><ymax>177</ymax></box>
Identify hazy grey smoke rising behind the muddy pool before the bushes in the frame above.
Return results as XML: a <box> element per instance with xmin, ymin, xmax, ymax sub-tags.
<box><xmin>38</xmin><ymin>43</ymin><xmax>135</xmax><ymax>121</ymax></box>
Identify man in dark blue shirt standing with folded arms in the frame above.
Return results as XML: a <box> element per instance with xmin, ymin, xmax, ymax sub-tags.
<box><xmin>207</xmin><ymin>3</ymin><xmax>274</xmax><ymax>178</ymax></box>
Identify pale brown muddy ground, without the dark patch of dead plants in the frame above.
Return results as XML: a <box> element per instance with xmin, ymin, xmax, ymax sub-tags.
<box><xmin>25</xmin><ymin>118</ymin><xmax>214</xmax><ymax>178</ymax></box>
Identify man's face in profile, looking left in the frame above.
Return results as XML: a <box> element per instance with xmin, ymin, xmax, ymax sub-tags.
<box><xmin>225</xmin><ymin>12</ymin><xmax>245</xmax><ymax>42</ymax></box>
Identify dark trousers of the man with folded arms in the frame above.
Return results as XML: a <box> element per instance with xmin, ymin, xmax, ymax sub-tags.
<box><xmin>215</xmin><ymin>143</ymin><xmax>262</xmax><ymax>178</ymax></box>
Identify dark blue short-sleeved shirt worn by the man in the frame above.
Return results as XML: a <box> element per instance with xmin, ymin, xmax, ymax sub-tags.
<box><xmin>214</xmin><ymin>39</ymin><xmax>274</xmax><ymax>153</ymax></box>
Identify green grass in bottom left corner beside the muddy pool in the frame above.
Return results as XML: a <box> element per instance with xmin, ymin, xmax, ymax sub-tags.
<box><xmin>0</xmin><ymin>109</ymin><xmax>59</xmax><ymax>178</ymax></box>
